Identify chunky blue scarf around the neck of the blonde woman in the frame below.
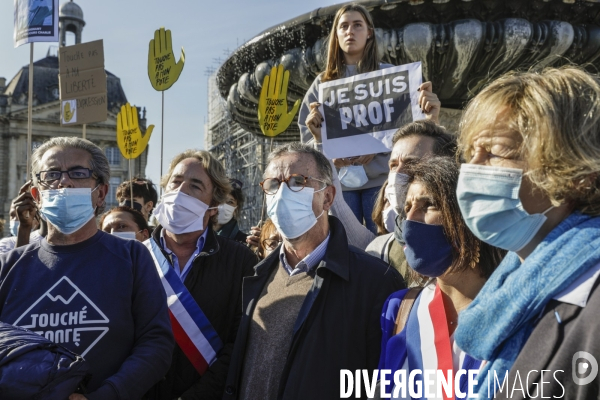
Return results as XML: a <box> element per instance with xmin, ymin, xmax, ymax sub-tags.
<box><xmin>454</xmin><ymin>212</ymin><xmax>600</xmax><ymax>399</ymax></box>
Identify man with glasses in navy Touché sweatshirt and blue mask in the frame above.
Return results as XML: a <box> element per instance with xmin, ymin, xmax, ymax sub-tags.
<box><xmin>0</xmin><ymin>137</ymin><xmax>174</xmax><ymax>400</ymax></box>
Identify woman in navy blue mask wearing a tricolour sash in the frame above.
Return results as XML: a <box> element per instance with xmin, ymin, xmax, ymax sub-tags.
<box><xmin>379</xmin><ymin>157</ymin><xmax>503</xmax><ymax>398</ymax></box>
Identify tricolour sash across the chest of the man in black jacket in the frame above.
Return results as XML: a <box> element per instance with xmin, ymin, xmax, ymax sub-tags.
<box><xmin>144</xmin><ymin>238</ymin><xmax>223</xmax><ymax>375</ymax></box>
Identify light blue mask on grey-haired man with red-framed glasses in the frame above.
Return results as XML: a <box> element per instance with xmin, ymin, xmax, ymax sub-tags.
<box><xmin>267</xmin><ymin>183</ymin><xmax>325</xmax><ymax>239</ymax></box>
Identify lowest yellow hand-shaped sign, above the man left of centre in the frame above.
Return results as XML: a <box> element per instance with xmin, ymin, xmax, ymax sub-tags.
<box><xmin>117</xmin><ymin>103</ymin><xmax>154</xmax><ymax>159</ymax></box>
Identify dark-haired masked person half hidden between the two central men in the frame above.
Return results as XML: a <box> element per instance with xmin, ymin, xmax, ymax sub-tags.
<box><xmin>213</xmin><ymin>179</ymin><xmax>248</xmax><ymax>244</ymax></box>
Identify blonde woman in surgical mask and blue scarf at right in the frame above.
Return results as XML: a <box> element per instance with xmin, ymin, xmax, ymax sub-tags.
<box><xmin>455</xmin><ymin>67</ymin><xmax>600</xmax><ymax>399</ymax></box>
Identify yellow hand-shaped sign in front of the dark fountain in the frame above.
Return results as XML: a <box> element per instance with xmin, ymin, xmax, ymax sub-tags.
<box><xmin>258</xmin><ymin>65</ymin><xmax>300</xmax><ymax>137</ymax></box>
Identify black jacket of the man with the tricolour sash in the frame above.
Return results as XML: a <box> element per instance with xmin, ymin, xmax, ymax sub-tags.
<box><xmin>148</xmin><ymin>225</ymin><xmax>258</xmax><ymax>400</ymax></box>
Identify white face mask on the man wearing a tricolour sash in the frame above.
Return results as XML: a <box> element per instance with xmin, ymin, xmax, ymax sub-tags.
<box><xmin>154</xmin><ymin>190</ymin><xmax>216</xmax><ymax>235</ymax></box>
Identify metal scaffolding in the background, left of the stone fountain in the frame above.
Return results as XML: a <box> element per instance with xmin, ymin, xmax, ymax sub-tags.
<box><xmin>204</xmin><ymin>68</ymin><xmax>284</xmax><ymax>233</ymax></box>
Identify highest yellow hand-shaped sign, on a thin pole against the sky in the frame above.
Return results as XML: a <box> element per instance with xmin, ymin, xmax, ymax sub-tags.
<box><xmin>148</xmin><ymin>28</ymin><xmax>185</xmax><ymax>91</ymax></box>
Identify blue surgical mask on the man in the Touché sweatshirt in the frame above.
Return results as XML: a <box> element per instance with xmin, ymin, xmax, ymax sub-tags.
<box><xmin>40</xmin><ymin>185</ymin><xmax>99</xmax><ymax>235</ymax></box>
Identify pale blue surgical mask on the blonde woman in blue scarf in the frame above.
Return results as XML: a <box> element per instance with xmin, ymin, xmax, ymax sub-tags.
<box><xmin>456</xmin><ymin>164</ymin><xmax>554</xmax><ymax>251</ymax></box>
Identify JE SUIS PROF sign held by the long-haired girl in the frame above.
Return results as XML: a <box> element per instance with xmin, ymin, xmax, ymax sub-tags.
<box><xmin>319</xmin><ymin>62</ymin><xmax>425</xmax><ymax>159</ymax></box>
